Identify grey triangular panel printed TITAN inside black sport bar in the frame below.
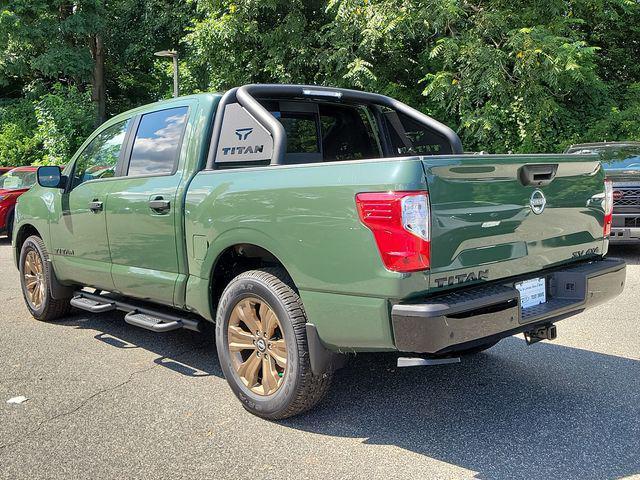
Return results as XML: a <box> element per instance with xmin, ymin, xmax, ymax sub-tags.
<box><xmin>216</xmin><ymin>103</ymin><xmax>273</xmax><ymax>163</ymax></box>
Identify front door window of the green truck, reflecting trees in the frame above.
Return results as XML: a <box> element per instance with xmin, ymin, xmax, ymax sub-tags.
<box><xmin>72</xmin><ymin>120</ymin><xmax>130</xmax><ymax>188</ymax></box>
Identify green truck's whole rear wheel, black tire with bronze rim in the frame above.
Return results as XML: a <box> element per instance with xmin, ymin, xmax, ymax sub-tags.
<box><xmin>215</xmin><ymin>267</ymin><xmax>333</xmax><ymax>420</ymax></box>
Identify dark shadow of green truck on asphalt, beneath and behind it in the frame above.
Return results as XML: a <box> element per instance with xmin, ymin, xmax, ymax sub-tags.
<box><xmin>58</xmin><ymin>313</ymin><xmax>640</xmax><ymax>479</ymax></box>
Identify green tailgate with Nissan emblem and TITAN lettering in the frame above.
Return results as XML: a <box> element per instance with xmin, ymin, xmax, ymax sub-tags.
<box><xmin>423</xmin><ymin>155</ymin><xmax>604</xmax><ymax>289</ymax></box>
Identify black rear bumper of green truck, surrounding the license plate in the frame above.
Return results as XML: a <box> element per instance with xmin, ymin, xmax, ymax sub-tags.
<box><xmin>391</xmin><ymin>259</ymin><xmax>626</xmax><ymax>353</ymax></box>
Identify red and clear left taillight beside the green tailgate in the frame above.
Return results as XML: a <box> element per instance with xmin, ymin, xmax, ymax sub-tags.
<box><xmin>356</xmin><ymin>192</ymin><xmax>431</xmax><ymax>272</ymax></box>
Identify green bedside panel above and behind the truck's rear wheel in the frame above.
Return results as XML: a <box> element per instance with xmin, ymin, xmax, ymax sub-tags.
<box><xmin>185</xmin><ymin>159</ymin><xmax>428</xmax><ymax>350</ymax></box>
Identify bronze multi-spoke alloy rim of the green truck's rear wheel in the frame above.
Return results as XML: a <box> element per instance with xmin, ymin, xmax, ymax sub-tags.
<box><xmin>227</xmin><ymin>297</ymin><xmax>287</xmax><ymax>395</ymax></box>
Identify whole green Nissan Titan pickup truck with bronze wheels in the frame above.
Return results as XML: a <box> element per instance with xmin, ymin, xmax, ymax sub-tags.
<box><xmin>13</xmin><ymin>85</ymin><xmax>625</xmax><ymax>419</ymax></box>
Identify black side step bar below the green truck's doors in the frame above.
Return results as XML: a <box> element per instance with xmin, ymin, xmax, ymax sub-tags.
<box><xmin>70</xmin><ymin>291</ymin><xmax>202</xmax><ymax>332</ymax></box>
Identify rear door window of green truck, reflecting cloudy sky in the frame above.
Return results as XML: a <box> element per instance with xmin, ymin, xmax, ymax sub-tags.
<box><xmin>127</xmin><ymin>107</ymin><xmax>188</xmax><ymax>176</ymax></box>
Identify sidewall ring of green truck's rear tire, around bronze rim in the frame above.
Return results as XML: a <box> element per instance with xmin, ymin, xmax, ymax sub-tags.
<box><xmin>215</xmin><ymin>277</ymin><xmax>301</xmax><ymax>416</ymax></box>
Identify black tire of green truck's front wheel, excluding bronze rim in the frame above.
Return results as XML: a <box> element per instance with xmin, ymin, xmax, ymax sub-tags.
<box><xmin>19</xmin><ymin>235</ymin><xmax>71</xmax><ymax>322</ymax></box>
